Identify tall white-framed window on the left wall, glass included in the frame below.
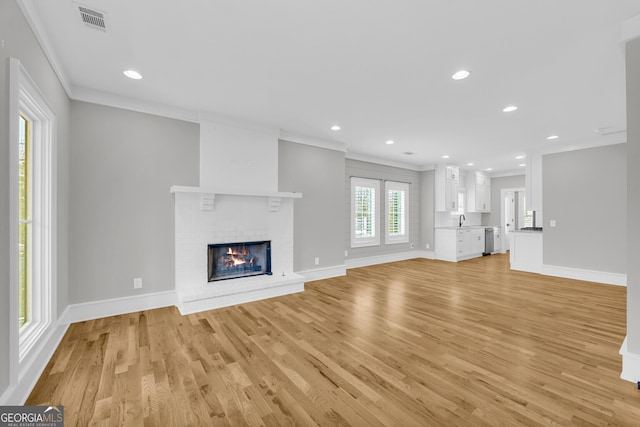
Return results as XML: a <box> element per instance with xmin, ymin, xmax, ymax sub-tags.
<box><xmin>9</xmin><ymin>59</ymin><xmax>56</xmax><ymax>369</ymax></box>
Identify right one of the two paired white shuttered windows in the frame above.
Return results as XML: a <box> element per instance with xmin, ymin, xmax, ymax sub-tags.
<box><xmin>384</xmin><ymin>181</ymin><xmax>409</xmax><ymax>244</ymax></box>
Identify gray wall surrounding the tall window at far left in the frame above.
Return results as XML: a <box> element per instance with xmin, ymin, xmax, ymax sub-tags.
<box><xmin>0</xmin><ymin>1</ymin><xmax>70</xmax><ymax>394</ymax></box>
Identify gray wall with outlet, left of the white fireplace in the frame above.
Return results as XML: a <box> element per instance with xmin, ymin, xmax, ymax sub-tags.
<box><xmin>69</xmin><ymin>101</ymin><xmax>199</xmax><ymax>303</ymax></box>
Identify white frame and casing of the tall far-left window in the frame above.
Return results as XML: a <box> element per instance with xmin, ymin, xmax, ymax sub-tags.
<box><xmin>9</xmin><ymin>58</ymin><xmax>57</xmax><ymax>372</ymax></box>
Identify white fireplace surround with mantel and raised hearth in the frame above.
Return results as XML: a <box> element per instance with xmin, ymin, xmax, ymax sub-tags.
<box><xmin>171</xmin><ymin>186</ymin><xmax>304</xmax><ymax>314</ymax></box>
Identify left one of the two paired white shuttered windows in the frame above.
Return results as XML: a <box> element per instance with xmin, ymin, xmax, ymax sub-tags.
<box><xmin>351</xmin><ymin>177</ymin><xmax>380</xmax><ymax>248</ymax></box>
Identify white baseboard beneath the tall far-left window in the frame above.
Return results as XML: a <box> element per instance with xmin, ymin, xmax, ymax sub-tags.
<box><xmin>0</xmin><ymin>321</ymin><xmax>69</xmax><ymax>406</ymax></box>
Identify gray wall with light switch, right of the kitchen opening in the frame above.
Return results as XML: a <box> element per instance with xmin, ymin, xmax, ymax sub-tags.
<box><xmin>542</xmin><ymin>144</ymin><xmax>627</xmax><ymax>274</ymax></box>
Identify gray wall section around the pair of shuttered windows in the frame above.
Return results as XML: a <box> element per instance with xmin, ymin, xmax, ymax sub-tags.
<box><xmin>343</xmin><ymin>159</ymin><xmax>422</xmax><ymax>259</ymax></box>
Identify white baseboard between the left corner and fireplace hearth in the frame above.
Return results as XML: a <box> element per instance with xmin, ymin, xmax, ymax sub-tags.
<box><xmin>60</xmin><ymin>291</ymin><xmax>178</xmax><ymax>323</ymax></box>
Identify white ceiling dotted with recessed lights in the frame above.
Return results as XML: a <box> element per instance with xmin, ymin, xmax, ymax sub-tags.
<box><xmin>24</xmin><ymin>0</ymin><xmax>640</xmax><ymax>172</ymax></box>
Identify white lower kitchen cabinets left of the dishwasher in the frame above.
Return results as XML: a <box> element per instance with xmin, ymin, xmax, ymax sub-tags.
<box><xmin>436</xmin><ymin>227</ymin><xmax>484</xmax><ymax>262</ymax></box>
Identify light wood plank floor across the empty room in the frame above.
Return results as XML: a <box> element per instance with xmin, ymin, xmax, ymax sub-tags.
<box><xmin>28</xmin><ymin>255</ymin><xmax>640</xmax><ymax>426</ymax></box>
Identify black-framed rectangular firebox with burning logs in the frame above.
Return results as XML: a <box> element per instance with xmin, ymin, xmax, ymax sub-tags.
<box><xmin>207</xmin><ymin>240</ymin><xmax>271</xmax><ymax>282</ymax></box>
